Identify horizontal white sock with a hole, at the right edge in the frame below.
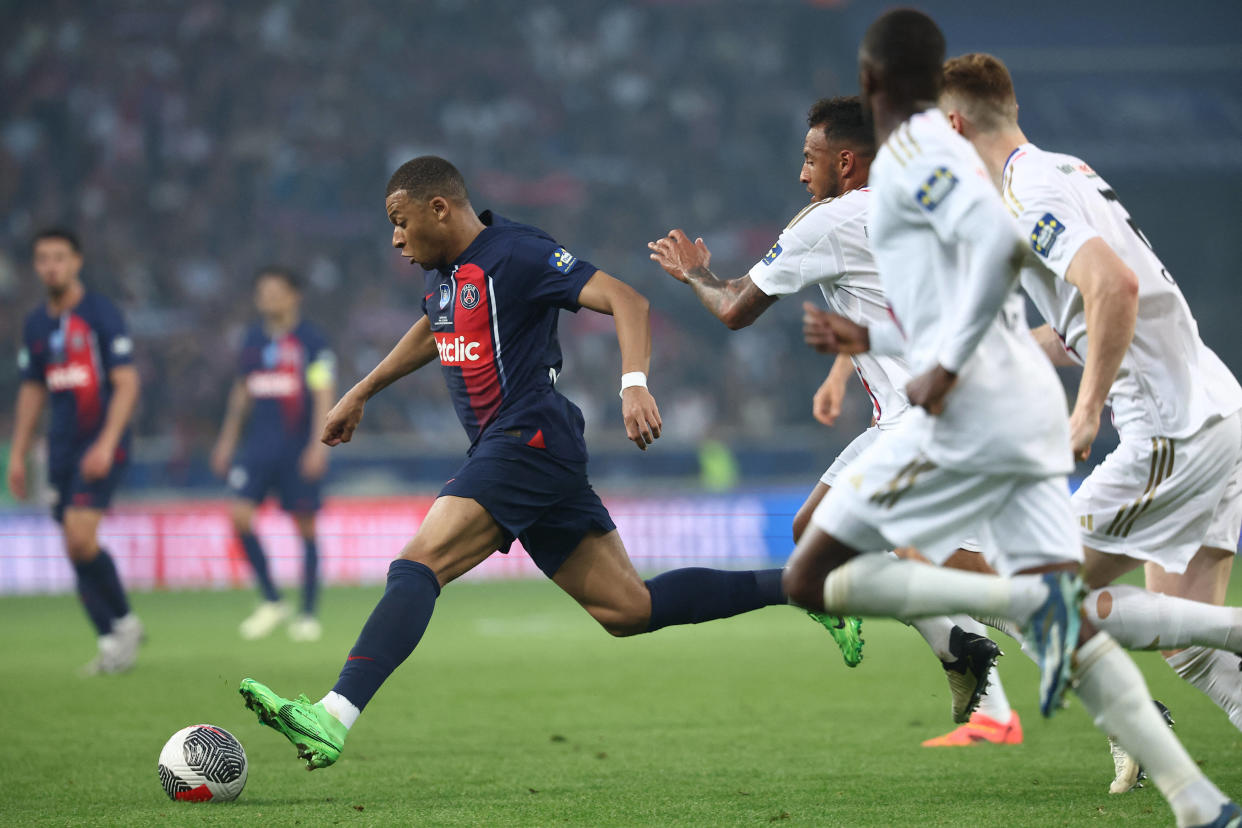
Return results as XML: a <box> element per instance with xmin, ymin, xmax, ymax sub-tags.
<box><xmin>1083</xmin><ymin>585</ymin><xmax>1242</xmax><ymax>650</ymax></box>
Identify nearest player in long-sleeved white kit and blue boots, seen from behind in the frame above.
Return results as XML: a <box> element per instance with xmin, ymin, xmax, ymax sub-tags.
<box><xmin>785</xmin><ymin>9</ymin><xmax>1242</xmax><ymax>826</ymax></box>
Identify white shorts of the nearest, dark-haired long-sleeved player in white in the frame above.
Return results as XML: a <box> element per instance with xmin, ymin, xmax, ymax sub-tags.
<box><xmin>811</xmin><ymin>428</ymin><xmax>1082</xmax><ymax>575</ymax></box>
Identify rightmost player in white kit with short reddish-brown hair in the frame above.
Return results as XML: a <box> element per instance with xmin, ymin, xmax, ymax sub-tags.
<box><xmin>940</xmin><ymin>55</ymin><xmax>1242</xmax><ymax>793</ymax></box>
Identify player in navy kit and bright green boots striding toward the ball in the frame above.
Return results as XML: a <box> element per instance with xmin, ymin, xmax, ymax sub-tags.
<box><xmin>241</xmin><ymin>156</ymin><xmax>809</xmax><ymax>768</ymax></box>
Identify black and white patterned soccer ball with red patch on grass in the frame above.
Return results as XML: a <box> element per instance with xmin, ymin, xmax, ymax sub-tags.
<box><xmin>159</xmin><ymin>725</ymin><xmax>247</xmax><ymax>802</ymax></box>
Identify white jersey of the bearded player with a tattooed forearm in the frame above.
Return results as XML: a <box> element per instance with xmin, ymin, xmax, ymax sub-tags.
<box><xmin>750</xmin><ymin>189</ymin><xmax>910</xmax><ymax>428</ymax></box>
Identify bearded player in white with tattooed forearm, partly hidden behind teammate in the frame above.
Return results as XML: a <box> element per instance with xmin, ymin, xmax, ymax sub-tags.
<box><xmin>648</xmin><ymin>97</ymin><xmax>1022</xmax><ymax>729</ymax></box>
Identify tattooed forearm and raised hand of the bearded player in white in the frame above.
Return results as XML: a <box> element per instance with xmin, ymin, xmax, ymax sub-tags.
<box><xmin>647</xmin><ymin>230</ymin><xmax>779</xmax><ymax>330</ymax></box>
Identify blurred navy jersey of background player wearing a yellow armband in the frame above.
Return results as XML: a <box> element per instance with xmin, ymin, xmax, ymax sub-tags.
<box><xmin>237</xmin><ymin>320</ymin><xmax>335</xmax><ymax>456</ymax></box>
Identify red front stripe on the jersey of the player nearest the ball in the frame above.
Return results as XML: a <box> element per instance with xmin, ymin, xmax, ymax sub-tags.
<box><xmin>435</xmin><ymin>264</ymin><xmax>504</xmax><ymax>431</ymax></box>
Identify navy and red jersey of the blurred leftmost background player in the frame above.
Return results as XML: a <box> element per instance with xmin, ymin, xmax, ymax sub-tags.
<box><xmin>17</xmin><ymin>290</ymin><xmax>133</xmax><ymax>469</ymax></box>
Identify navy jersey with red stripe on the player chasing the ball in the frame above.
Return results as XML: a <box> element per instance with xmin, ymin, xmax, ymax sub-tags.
<box><xmin>422</xmin><ymin>211</ymin><xmax>595</xmax><ymax>462</ymax></box>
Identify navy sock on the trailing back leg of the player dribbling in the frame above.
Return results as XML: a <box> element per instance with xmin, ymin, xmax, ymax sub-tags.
<box><xmin>647</xmin><ymin>567</ymin><xmax>787</xmax><ymax>632</ymax></box>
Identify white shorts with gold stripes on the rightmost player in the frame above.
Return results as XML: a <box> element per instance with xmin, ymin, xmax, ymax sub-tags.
<box><xmin>1073</xmin><ymin>413</ymin><xmax>1242</xmax><ymax>572</ymax></box>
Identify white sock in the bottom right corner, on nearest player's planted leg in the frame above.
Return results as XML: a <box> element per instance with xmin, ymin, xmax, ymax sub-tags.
<box><xmin>1074</xmin><ymin>633</ymin><xmax>1227</xmax><ymax>826</ymax></box>
